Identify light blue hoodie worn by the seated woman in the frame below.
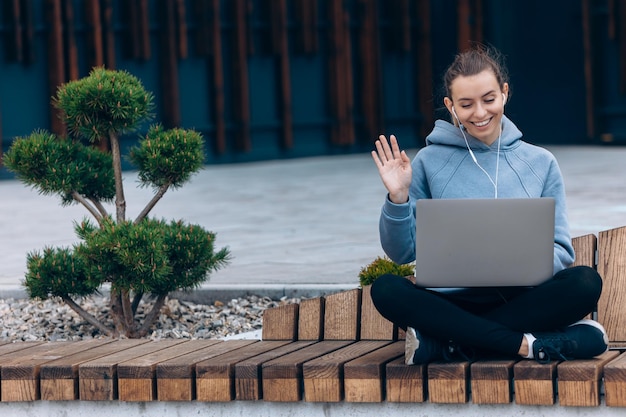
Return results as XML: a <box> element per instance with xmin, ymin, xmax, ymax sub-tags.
<box><xmin>379</xmin><ymin>116</ymin><xmax>574</xmax><ymax>273</ymax></box>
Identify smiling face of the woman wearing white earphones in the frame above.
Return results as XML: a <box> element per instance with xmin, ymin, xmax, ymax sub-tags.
<box><xmin>444</xmin><ymin>69</ymin><xmax>509</xmax><ymax>145</ymax></box>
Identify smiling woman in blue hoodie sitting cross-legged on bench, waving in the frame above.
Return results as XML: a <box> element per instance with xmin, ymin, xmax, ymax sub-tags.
<box><xmin>372</xmin><ymin>47</ymin><xmax>608</xmax><ymax>364</ymax></box>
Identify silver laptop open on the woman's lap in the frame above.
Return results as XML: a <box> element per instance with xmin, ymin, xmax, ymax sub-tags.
<box><xmin>415</xmin><ymin>198</ymin><xmax>554</xmax><ymax>288</ymax></box>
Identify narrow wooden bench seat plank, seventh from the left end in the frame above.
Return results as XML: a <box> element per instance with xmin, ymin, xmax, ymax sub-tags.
<box><xmin>235</xmin><ymin>341</ymin><xmax>314</xmax><ymax>401</ymax></box>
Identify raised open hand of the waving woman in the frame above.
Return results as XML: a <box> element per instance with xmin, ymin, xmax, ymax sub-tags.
<box><xmin>372</xmin><ymin>135</ymin><xmax>413</xmax><ymax>204</ymax></box>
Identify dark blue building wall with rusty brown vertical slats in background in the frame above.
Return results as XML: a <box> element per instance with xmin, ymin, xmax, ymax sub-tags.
<box><xmin>0</xmin><ymin>0</ymin><xmax>626</xmax><ymax>175</ymax></box>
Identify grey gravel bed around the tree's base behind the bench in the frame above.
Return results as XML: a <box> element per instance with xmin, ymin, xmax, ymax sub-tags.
<box><xmin>0</xmin><ymin>296</ymin><xmax>299</xmax><ymax>342</ymax></box>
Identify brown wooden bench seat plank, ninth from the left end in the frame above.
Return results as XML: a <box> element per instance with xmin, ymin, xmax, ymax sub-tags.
<box><xmin>302</xmin><ymin>341</ymin><xmax>389</xmax><ymax>402</ymax></box>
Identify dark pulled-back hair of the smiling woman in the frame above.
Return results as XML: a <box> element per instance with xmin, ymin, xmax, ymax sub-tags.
<box><xmin>443</xmin><ymin>45</ymin><xmax>509</xmax><ymax>97</ymax></box>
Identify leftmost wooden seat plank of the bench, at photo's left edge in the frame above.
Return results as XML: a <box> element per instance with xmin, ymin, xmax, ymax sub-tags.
<box><xmin>0</xmin><ymin>340</ymin><xmax>103</xmax><ymax>402</ymax></box>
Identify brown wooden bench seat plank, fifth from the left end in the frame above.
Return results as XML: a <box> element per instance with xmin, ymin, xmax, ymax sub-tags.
<box><xmin>156</xmin><ymin>340</ymin><xmax>256</xmax><ymax>401</ymax></box>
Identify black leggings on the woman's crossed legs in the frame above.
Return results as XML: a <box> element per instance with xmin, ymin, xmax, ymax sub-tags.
<box><xmin>371</xmin><ymin>266</ymin><xmax>602</xmax><ymax>355</ymax></box>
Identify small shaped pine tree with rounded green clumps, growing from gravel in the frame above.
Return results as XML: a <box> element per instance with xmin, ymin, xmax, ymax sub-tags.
<box><xmin>4</xmin><ymin>68</ymin><xmax>230</xmax><ymax>337</ymax></box>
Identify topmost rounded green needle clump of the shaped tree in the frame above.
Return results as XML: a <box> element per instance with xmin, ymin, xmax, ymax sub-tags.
<box><xmin>54</xmin><ymin>67</ymin><xmax>154</xmax><ymax>143</ymax></box>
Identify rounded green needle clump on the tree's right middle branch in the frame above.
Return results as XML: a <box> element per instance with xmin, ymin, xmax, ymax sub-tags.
<box><xmin>129</xmin><ymin>125</ymin><xmax>204</xmax><ymax>188</ymax></box>
